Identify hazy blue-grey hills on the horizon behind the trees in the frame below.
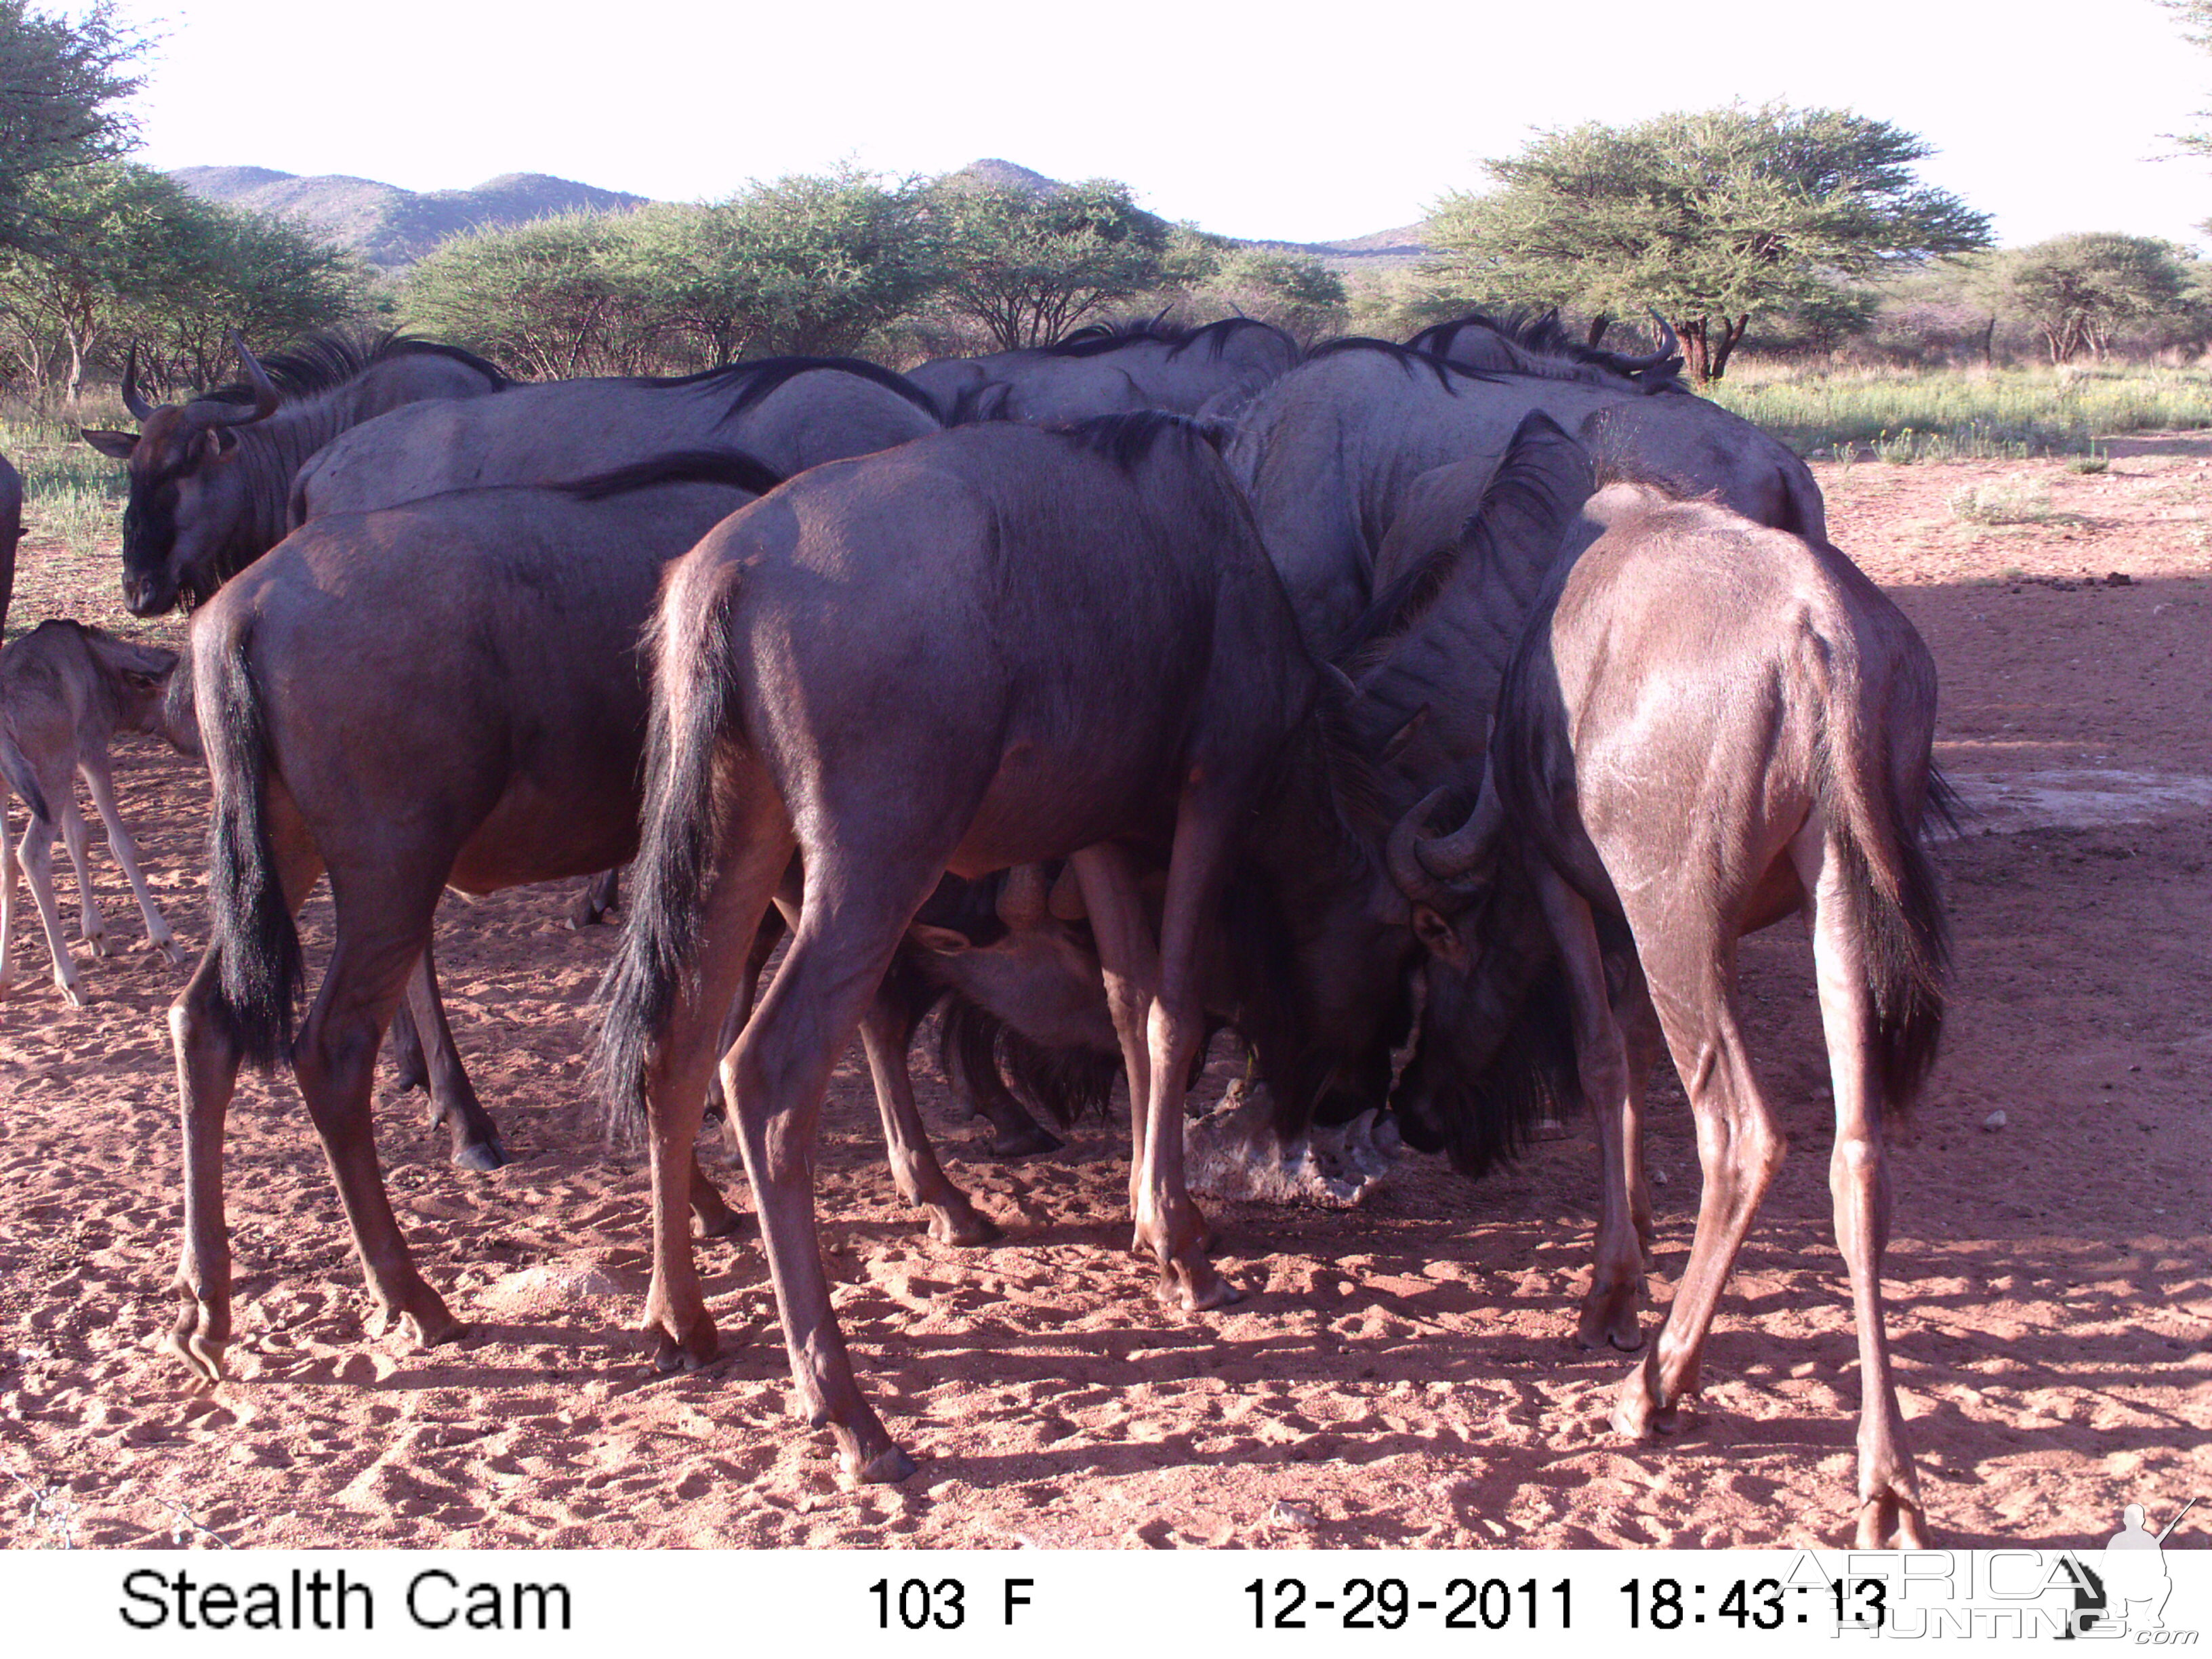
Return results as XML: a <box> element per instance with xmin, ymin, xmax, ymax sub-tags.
<box><xmin>170</xmin><ymin>155</ymin><xmax>1429</xmax><ymax>274</ymax></box>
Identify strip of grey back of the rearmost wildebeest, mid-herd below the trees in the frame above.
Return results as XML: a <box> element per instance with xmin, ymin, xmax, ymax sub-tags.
<box><xmin>907</xmin><ymin>316</ymin><xmax>1298</xmax><ymax>425</ymax></box>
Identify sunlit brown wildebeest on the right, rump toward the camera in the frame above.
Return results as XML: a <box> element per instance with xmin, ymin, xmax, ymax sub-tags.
<box><xmin>1398</xmin><ymin>451</ymin><xmax>1944</xmax><ymax>1549</ymax></box>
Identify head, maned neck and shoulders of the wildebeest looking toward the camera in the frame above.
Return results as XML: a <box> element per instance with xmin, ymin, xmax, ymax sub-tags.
<box><xmin>84</xmin><ymin>334</ymin><xmax>506</xmax><ymax>617</ymax></box>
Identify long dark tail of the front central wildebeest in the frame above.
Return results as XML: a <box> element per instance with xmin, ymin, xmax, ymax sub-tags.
<box><xmin>597</xmin><ymin>586</ymin><xmax>737</xmax><ymax>1139</ymax></box>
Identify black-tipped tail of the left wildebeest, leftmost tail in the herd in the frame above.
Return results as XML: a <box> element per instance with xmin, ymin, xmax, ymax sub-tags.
<box><xmin>192</xmin><ymin>630</ymin><xmax>303</xmax><ymax>1071</ymax></box>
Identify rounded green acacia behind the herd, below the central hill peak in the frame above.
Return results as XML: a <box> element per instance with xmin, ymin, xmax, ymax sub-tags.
<box><xmin>931</xmin><ymin>179</ymin><xmax>1168</xmax><ymax>352</ymax></box>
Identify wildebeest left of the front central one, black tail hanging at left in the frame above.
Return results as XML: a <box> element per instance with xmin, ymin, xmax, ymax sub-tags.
<box><xmin>168</xmin><ymin>453</ymin><xmax>1159</xmax><ymax>1378</ymax></box>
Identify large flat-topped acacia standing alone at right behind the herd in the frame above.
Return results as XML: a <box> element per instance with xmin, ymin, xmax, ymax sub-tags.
<box><xmin>1427</xmin><ymin>104</ymin><xmax>1988</xmax><ymax>380</ymax></box>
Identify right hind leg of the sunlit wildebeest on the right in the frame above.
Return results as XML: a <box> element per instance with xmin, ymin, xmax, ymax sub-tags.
<box><xmin>1790</xmin><ymin>814</ymin><xmax>1927</xmax><ymax>1551</ymax></box>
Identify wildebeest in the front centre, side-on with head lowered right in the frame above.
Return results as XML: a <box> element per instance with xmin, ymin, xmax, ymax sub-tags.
<box><xmin>602</xmin><ymin>413</ymin><xmax>1442</xmax><ymax>1480</ymax></box>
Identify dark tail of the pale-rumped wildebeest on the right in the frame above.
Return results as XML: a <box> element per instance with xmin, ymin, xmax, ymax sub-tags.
<box><xmin>1820</xmin><ymin>650</ymin><xmax>1955</xmax><ymax>1113</ymax></box>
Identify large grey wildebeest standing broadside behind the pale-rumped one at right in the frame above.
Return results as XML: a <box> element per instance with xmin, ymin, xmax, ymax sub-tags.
<box><xmin>1230</xmin><ymin>341</ymin><xmax>1825</xmax><ymax>648</ymax></box>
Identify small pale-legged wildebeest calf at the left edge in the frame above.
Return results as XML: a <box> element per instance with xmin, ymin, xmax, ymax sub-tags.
<box><xmin>0</xmin><ymin>619</ymin><xmax>184</xmax><ymax>1008</ymax></box>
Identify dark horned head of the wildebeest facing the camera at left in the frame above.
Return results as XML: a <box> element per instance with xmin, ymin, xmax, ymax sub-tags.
<box><xmin>84</xmin><ymin>336</ymin><xmax>281</xmax><ymax>617</ymax></box>
